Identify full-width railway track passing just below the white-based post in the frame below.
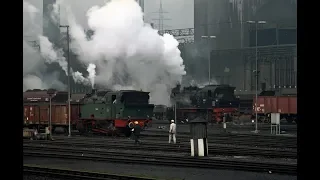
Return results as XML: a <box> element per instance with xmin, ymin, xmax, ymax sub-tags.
<box><xmin>23</xmin><ymin>147</ymin><xmax>297</xmax><ymax>175</ymax></box>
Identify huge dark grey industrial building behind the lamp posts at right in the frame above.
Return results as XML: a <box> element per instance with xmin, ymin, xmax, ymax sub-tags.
<box><xmin>193</xmin><ymin>0</ymin><xmax>297</xmax><ymax>91</ymax></box>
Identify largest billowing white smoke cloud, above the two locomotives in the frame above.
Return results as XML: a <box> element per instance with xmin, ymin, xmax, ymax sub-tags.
<box><xmin>68</xmin><ymin>0</ymin><xmax>186</xmax><ymax>105</ymax></box>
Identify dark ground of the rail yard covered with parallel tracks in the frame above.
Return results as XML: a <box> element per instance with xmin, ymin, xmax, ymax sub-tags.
<box><xmin>23</xmin><ymin>123</ymin><xmax>297</xmax><ymax>179</ymax></box>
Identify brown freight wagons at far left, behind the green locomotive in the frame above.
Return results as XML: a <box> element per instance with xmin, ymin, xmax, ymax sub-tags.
<box><xmin>24</xmin><ymin>90</ymin><xmax>84</xmax><ymax>132</ymax></box>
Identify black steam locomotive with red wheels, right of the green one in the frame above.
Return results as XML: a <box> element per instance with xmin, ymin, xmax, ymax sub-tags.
<box><xmin>172</xmin><ymin>85</ymin><xmax>240</xmax><ymax>123</ymax></box>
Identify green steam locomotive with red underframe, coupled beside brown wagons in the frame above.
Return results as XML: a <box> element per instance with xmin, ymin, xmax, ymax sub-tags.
<box><xmin>77</xmin><ymin>90</ymin><xmax>154</xmax><ymax>136</ymax></box>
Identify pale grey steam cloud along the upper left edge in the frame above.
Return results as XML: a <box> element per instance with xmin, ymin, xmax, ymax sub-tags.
<box><xmin>23</xmin><ymin>0</ymin><xmax>65</xmax><ymax>91</ymax></box>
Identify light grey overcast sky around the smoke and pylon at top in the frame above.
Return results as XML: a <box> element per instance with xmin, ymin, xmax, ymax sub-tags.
<box><xmin>26</xmin><ymin>0</ymin><xmax>193</xmax><ymax>29</ymax></box>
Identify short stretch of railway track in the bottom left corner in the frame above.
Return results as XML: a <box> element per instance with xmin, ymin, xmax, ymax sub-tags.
<box><xmin>23</xmin><ymin>165</ymin><xmax>155</xmax><ymax>180</ymax></box>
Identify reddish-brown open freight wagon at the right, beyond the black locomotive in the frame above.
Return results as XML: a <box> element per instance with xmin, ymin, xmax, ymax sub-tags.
<box><xmin>253</xmin><ymin>96</ymin><xmax>297</xmax><ymax>122</ymax></box>
